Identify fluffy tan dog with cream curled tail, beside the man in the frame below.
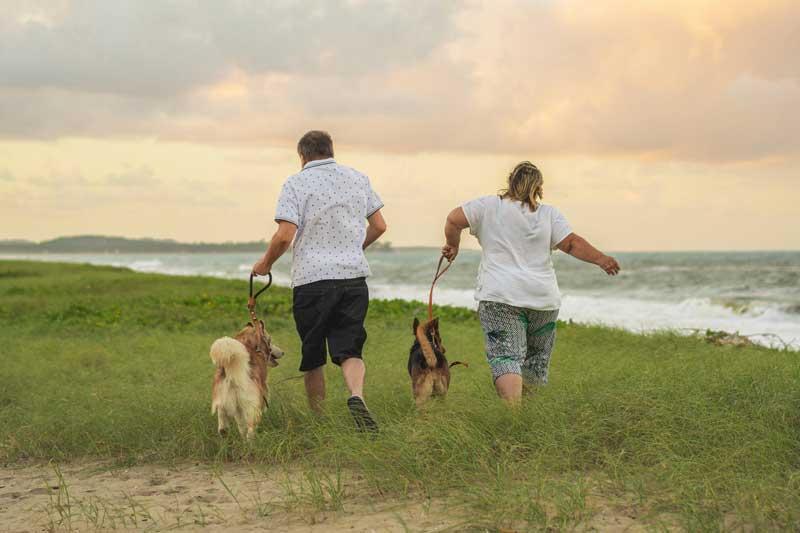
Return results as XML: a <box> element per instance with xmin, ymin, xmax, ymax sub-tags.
<box><xmin>211</xmin><ymin>320</ymin><xmax>283</xmax><ymax>439</ymax></box>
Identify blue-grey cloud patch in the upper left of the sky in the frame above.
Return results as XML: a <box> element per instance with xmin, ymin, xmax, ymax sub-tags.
<box><xmin>0</xmin><ymin>0</ymin><xmax>454</xmax><ymax>98</ymax></box>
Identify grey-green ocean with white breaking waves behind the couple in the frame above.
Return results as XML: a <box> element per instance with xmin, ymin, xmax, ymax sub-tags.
<box><xmin>0</xmin><ymin>248</ymin><xmax>800</xmax><ymax>348</ymax></box>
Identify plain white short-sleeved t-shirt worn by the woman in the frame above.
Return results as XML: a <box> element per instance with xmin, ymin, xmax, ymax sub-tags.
<box><xmin>461</xmin><ymin>196</ymin><xmax>572</xmax><ymax>311</ymax></box>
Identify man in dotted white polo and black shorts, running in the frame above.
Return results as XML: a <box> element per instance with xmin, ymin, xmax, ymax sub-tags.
<box><xmin>253</xmin><ymin>131</ymin><xmax>386</xmax><ymax>431</ymax></box>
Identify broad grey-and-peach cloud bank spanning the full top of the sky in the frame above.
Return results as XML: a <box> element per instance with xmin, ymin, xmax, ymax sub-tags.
<box><xmin>0</xmin><ymin>0</ymin><xmax>800</xmax><ymax>162</ymax></box>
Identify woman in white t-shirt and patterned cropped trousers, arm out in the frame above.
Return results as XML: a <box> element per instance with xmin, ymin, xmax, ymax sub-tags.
<box><xmin>442</xmin><ymin>161</ymin><xmax>619</xmax><ymax>404</ymax></box>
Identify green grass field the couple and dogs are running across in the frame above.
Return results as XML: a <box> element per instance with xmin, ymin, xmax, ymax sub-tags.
<box><xmin>0</xmin><ymin>262</ymin><xmax>800</xmax><ymax>530</ymax></box>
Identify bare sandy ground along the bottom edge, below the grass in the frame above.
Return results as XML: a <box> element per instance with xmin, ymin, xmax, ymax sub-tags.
<box><xmin>0</xmin><ymin>463</ymin><xmax>672</xmax><ymax>532</ymax></box>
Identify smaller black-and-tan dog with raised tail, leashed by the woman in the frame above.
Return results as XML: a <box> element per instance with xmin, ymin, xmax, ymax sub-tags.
<box><xmin>408</xmin><ymin>318</ymin><xmax>469</xmax><ymax>407</ymax></box>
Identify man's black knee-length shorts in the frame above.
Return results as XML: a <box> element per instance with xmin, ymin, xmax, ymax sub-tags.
<box><xmin>293</xmin><ymin>278</ymin><xmax>369</xmax><ymax>372</ymax></box>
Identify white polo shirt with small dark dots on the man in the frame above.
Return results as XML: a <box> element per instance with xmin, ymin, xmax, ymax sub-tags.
<box><xmin>275</xmin><ymin>158</ymin><xmax>383</xmax><ymax>287</ymax></box>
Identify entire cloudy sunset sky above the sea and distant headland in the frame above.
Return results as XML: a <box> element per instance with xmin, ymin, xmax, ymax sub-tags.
<box><xmin>0</xmin><ymin>0</ymin><xmax>800</xmax><ymax>251</ymax></box>
